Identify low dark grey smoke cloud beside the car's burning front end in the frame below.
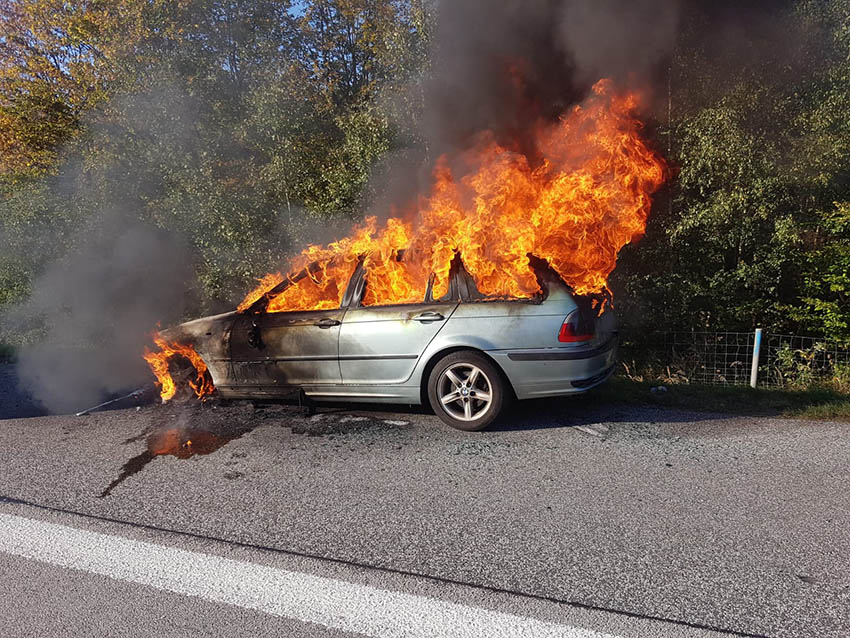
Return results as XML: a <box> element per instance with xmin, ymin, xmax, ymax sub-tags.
<box><xmin>7</xmin><ymin>221</ymin><xmax>189</xmax><ymax>412</ymax></box>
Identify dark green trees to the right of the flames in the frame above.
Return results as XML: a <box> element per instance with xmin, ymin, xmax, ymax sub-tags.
<box><xmin>614</xmin><ymin>0</ymin><xmax>850</xmax><ymax>343</ymax></box>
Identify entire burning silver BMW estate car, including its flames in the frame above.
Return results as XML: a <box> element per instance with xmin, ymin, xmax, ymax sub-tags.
<box><xmin>145</xmin><ymin>80</ymin><xmax>666</xmax><ymax>430</ymax></box>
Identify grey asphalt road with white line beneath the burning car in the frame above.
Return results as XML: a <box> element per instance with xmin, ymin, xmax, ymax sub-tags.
<box><xmin>0</xmin><ymin>395</ymin><xmax>850</xmax><ymax>638</ymax></box>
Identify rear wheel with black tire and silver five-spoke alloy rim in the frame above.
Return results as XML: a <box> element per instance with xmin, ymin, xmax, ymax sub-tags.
<box><xmin>428</xmin><ymin>350</ymin><xmax>506</xmax><ymax>432</ymax></box>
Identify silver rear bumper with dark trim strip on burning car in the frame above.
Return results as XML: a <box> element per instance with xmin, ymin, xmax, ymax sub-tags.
<box><xmin>488</xmin><ymin>335</ymin><xmax>619</xmax><ymax>399</ymax></box>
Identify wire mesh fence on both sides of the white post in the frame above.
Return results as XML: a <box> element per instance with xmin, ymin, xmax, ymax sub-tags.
<box><xmin>627</xmin><ymin>332</ymin><xmax>850</xmax><ymax>389</ymax></box>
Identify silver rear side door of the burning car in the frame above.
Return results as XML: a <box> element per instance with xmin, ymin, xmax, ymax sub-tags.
<box><xmin>339</xmin><ymin>273</ymin><xmax>457</xmax><ymax>385</ymax></box>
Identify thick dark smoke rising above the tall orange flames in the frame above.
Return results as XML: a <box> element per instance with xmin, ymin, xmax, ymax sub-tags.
<box><xmin>425</xmin><ymin>0</ymin><xmax>679</xmax><ymax>159</ymax></box>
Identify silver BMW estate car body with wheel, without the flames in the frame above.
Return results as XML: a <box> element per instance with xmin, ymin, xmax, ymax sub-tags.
<box><xmin>163</xmin><ymin>259</ymin><xmax>617</xmax><ymax>430</ymax></box>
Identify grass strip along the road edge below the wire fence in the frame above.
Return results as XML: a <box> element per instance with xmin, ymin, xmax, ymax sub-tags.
<box><xmin>594</xmin><ymin>377</ymin><xmax>850</xmax><ymax>421</ymax></box>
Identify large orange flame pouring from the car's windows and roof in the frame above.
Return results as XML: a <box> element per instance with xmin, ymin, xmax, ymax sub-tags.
<box><xmin>239</xmin><ymin>80</ymin><xmax>666</xmax><ymax>312</ymax></box>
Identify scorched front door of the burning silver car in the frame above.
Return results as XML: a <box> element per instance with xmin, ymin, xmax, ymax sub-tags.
<box><xmin>230</xmin><ymin>309</ymin><xmax>345</xmax><ymax>395</ymax></box>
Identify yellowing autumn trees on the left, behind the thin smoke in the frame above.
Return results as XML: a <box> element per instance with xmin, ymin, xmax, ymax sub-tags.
<box><xmin>0</xmin><ymin>0</ymin><xmax>425</xmax><ymax>324</ymax></box>
